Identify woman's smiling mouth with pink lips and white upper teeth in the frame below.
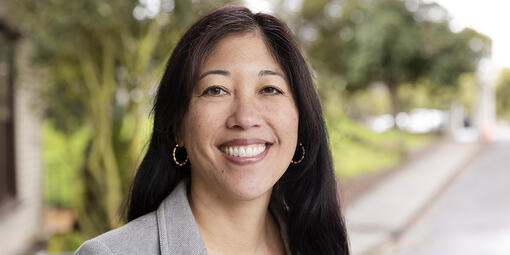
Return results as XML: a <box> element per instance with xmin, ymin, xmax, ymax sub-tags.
<box><xmin>218</xmin><ymin>139</ymin><xmax>272</xmax><ymax>165</ymax></box>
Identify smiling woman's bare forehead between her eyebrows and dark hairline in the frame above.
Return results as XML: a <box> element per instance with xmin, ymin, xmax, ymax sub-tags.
<box><xmin>200</xmin><ymin>32</ymin><xmax>281</xmax><ymax>72</ymax></box>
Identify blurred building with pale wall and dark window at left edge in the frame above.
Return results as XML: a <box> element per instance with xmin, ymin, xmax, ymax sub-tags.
<box><xmin>0</xmin><ymin>0</ymin><xmax>43</xmax><ymax>255</ymax></box>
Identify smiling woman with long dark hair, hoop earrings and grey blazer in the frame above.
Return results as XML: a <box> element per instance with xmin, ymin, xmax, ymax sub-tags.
<box><xmin>76</xmin><ymin>6</ymin><xmax>349</xmax><ymax>254</ymax></box>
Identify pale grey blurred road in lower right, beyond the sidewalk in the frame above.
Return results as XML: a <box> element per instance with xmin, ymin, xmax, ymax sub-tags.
<box><xmin>373</xmin><ymin>140</ymin><xmax>510</xmax><ymax>255</ymax></box>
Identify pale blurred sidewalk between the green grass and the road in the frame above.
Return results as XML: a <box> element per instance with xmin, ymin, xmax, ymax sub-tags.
<box><xmin>344</xmin><ymin>140</ymin><xmax>482</xmax><ymax>255</ymax></box>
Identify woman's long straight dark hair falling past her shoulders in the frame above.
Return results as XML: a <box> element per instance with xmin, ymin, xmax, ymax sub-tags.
<box><xmin>128</xmin><ymin>6</ymin><xmax>349</xmax><ymax>254</ymax></box>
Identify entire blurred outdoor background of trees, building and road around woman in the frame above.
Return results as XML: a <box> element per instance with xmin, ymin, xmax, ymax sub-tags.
<box><xmin>0</xmin><ymin>0</ymin><xmax>510</xmax><ymax>255</ymax></box>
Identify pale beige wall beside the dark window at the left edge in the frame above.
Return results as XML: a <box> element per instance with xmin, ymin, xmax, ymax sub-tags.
<box><xmin>0</xmin><ymin>11</ymin><xmax>42</xmax><ymax>255</ymax></box>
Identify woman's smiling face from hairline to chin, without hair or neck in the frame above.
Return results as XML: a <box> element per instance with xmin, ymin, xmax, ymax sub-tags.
<box><xmin>180</xmin><ymin>32</ymin><xmax>298</xmax><ymax>200</ymax></box>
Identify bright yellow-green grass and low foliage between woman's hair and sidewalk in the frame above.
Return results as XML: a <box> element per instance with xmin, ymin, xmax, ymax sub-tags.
<box><xmin>319</xmin><ymin>79</ymin><xmax>435</xmax><ymax>178</ymax></box>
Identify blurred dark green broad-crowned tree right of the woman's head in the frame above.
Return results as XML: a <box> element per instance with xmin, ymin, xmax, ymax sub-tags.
<box><xmin>298</xmin><ymin>0</ymin><xmax>490</xmax><ymax>114</ymax></box>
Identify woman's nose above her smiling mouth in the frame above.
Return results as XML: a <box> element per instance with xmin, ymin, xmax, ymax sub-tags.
<box><xmin>227</xmin><ymin>92</ymin><xmax>262</xmax><ymax>130</ymax></box>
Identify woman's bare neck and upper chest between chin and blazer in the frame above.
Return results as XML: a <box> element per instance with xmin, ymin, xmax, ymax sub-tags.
<box><xmin>188</xmin><ymin>178</ymin><xmax>284</xmax><ymax>254</ymax></box>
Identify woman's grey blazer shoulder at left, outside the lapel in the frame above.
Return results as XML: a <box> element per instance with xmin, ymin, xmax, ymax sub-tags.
<box><xmin>75</xmin><ymin>212</ymin><xmax>159</xmax><ymax>255</ymax></box>
